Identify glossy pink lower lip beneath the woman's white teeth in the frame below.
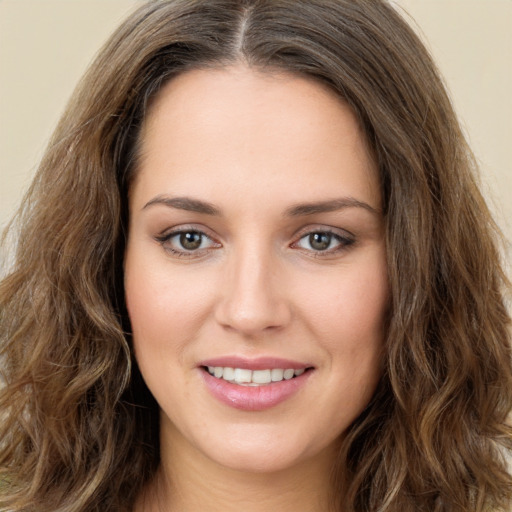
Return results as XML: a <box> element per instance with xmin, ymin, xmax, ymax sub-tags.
<box><xmin>201</xmin><ymin>369</ymin><xmax>312</xmax><ymax>411</ymax></box>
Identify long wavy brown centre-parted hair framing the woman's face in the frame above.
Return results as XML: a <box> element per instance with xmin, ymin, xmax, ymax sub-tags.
<box><xmin>0</xmin><ymin>0</ymin><xmax>512</xmax><ymax>512</ymax></box>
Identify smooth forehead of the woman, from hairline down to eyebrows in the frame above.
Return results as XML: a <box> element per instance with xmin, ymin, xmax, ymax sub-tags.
<box><xmin>135</xmin><ymin>65</ymin><xmax>380</xmax><ymax>212</ymax></box>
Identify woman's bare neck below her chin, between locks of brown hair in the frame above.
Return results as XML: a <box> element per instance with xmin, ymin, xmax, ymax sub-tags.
<box><xmin>135</xmin><ymin>420</ymin><xmax>340</xmax><ymax>512</ymax></box>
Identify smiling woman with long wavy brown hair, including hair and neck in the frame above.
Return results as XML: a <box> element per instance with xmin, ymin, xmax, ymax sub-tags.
<box><xmin>0</xmin><ymin>0</ymin><xmax>512</xmax><ymax>512</ymax></box>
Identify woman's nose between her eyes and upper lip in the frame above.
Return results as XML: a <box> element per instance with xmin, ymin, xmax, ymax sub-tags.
<box><xmin>216</xmin><ymin>244</ymin><xmax>291</xmax><ymax>337</ymax></box>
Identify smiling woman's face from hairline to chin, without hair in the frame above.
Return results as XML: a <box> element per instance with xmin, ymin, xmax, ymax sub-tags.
<box><xmin>125</xmin><ymin>66</ymin><xmax>388</xmax><ymax>471</ymax></box>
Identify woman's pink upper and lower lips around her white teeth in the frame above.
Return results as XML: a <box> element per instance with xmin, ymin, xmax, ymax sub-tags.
<box><xmin>199</xmin><ymin>357</ymin><xmax>313</xmax><ymax>411</ymax></box>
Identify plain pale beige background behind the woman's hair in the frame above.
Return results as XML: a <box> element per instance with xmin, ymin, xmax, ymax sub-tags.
<box><xmin>0</xmin><ymin>0</ymin><xmax>512</xmax><ymax>270</ymax></box>
